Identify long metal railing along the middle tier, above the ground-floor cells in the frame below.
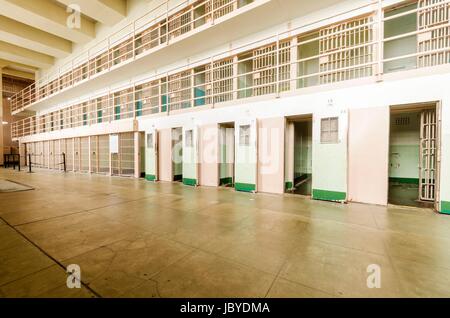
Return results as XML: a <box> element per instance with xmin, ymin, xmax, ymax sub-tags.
<box><xmin>12</xmin><ymin>0</ymin><xmax>450</xmax><ymax>138</ymax></box>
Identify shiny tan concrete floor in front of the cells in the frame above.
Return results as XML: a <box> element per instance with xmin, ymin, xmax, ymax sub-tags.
<box><xmin>0</xmin><ymin>169</ymin><xmax>450</xmax><ymax>297</ymax></box>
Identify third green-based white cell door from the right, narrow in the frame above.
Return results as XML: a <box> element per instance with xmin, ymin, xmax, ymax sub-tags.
<box><xmin>183</xmin><ymin>125</ymin><xmax>199</xmax><ymax>186</ymax></box>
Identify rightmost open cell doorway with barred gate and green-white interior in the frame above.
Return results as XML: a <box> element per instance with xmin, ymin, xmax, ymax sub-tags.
<box><xmin>388</xmin><ymin>104</ymin><xmax>440</xmax><ymax>208</ymax></box>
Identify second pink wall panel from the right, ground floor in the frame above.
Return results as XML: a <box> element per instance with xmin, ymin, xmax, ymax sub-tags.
<box><xmin>258</xmin><ymin>117</ymin><xmax>285</xmax><ymax>194</ymax></box>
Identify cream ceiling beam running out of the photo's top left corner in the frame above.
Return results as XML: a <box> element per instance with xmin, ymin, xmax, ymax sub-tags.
<box><xmin>0</xmin><ymin>0</ymin><xmax>95</xmax><ymax>43</ymax></box>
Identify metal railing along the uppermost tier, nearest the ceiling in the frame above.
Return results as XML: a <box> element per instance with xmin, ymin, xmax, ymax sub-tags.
<box><xmin>11</xmin><ymin>0</ymin><xmax>254</xmax><ymax>112</ymax></box>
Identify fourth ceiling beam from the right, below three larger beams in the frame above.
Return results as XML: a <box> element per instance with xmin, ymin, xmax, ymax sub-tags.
<box><xmin>0</xmin><ymin>41</ymin><xmax>55</xmax><ymax>68</ymax></box>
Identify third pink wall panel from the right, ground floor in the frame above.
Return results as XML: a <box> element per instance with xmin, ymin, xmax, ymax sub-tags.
<box><xmin>199</xmin><ymin>124</ymin><xmax>219</xmax><ymax>187</ymax></box>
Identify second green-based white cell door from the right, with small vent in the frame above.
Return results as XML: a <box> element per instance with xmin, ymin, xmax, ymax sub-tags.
<box><xmin>235</xmin><ymin>119</ymin><xmax>258</xmax><ymax>192</ymax></box>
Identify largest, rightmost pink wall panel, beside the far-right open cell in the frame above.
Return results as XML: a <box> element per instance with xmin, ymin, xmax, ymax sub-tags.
<box><xmin>348</xmin><ymin>107</ymin><xmax>389</xmax><ymax>205</ymax></box>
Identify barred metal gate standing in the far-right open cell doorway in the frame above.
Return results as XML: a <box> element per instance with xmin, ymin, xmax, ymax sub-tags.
<box><xmin>419</xmin><ymin>109</ymin><xmax>438</xmax><ymax>202</ymax></box>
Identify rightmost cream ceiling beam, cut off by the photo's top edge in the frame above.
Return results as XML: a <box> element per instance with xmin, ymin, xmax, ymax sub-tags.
<box><xmin>57</xmin><ymin>0</ymin><xmax>127</xmax><ymax>26</ymax></box>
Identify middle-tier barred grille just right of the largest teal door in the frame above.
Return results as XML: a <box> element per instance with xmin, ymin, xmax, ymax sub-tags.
<box><xmin>206</xmin><ymin>58</ymin><xmax>233</xmax><ymax>104</ymax></box>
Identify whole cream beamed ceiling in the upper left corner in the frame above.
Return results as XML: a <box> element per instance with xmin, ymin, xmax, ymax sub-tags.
<box><xmin>0</xmin><ymin>0</ymin><xmax>127</xmax><ymax>79</ymax></box>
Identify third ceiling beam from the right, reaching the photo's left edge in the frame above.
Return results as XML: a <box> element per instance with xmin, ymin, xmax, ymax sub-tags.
<box><xmin>0</xmin><ymin>16</ymin><xmax>72</xmax><ymax>58</ymax></box>
